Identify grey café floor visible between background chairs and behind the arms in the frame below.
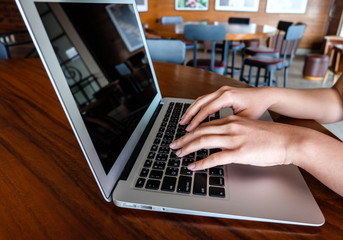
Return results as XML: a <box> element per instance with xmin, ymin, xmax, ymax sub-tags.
<box><xmin>186</xmin><ymin>51</ymin><xmax>343</xmax><ymax>141</ymax></box>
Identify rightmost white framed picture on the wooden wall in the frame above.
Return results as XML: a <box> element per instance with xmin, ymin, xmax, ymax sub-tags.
<box><xmin>266</xmin><ymin>0</ymin><xmax>307</xmax><ymax>13</ymax></box>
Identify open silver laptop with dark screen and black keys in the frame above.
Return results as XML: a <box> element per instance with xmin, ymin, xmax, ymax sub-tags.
<box><xmin>16</xmin><ymin>0</ymin><xmax>325</xmax><ymax>226</ymax></box>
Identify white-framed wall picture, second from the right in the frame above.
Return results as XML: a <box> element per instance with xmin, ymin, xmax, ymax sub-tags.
<box><xmin>214</xmin><ymin>0</ymin><xmax>260</xmax><ymax>12</ymax></box>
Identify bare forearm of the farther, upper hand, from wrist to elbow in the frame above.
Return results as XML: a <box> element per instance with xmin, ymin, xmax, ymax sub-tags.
<box><xmin>265</xmin><ymin>88</ymin><xmax>343</xmax><ymax>123</ymax></box>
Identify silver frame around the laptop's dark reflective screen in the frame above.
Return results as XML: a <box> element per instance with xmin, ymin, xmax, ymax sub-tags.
<box><xmin>16</xmin><ymin>0</ymin><xmax>162</xmax><ymax>202</ymax></box>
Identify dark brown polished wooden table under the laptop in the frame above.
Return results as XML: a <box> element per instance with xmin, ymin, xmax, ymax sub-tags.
<box><xmin>0</xmin><ymin>59</ymin><xmax>343</xmax><ymax>240</ymax></box>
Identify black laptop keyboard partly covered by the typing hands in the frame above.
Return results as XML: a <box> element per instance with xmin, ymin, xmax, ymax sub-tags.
<box><xmin>135</xmin><ymin>103</ymin><xmax>225</xmax><ymax>198</ymax></box>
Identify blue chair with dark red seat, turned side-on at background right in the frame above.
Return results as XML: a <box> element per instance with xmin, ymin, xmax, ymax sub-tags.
<box><xmin>240</xmin><ymin>25</ymin><xmax>306</xmax><ymax>87</ymax></box>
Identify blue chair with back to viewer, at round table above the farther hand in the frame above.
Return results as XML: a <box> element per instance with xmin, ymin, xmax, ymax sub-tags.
<box><xmin>184</xmin><ymin>24</ymin><xmax>228</xmax><ymax>75</ymax></box>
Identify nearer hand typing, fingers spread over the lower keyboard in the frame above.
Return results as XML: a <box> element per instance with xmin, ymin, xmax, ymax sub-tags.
<box><xmin>170</xmin><ymin>115</ymin><xmax>307</xmax><ymax>170</ymax></box>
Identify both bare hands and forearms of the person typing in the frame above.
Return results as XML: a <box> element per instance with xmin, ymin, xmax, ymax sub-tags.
<box><xmin>170</xmin><ymin>78</ymin><xmax>343</xmax><ymax>196</ymax></box>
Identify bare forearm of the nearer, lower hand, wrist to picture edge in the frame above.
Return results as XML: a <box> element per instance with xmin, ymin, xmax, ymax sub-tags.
<box><xmin>288</xmin><ymin>129</ymin><xmax>343</xmax><ymax>196</ymax></box>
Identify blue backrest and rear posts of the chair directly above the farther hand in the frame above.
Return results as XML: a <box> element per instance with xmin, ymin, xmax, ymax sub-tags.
<box><xmin>183</xmin><ymin>24</ymin><xmax>228</xmax><ymax>71</ymax></box>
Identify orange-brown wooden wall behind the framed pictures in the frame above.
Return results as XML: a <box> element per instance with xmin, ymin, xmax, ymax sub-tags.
<box><xmin>140</xmin><ymin>0</ymin><xmax>332</xmax><ymax>50</ymax></box>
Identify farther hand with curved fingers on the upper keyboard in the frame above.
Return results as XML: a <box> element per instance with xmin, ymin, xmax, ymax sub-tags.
<box><xmin>180</xmin><ymin>86</ymin><xmax>271</xmax><ymax>131</ymax></box>
